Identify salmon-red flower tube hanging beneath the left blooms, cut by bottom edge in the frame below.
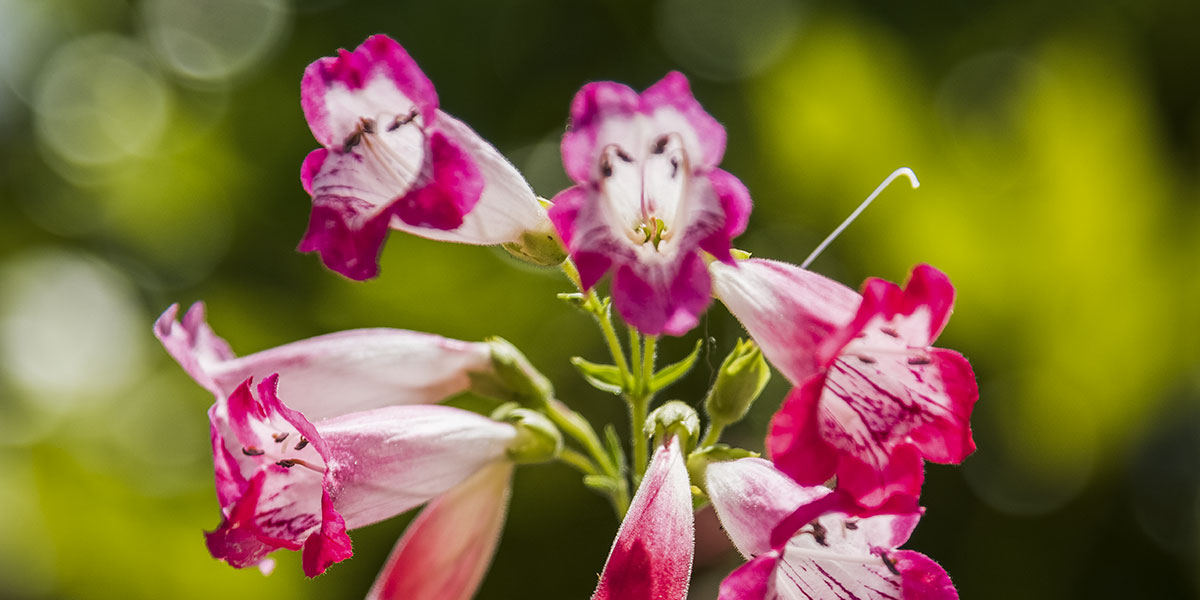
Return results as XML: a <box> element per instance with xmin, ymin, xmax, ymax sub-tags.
<box><xmin>367</xmin><ymin>462</ymin><xmax>512</xmax><ymax>600</ymax></box>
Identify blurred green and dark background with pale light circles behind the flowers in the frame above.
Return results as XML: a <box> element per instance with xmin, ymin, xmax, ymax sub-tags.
<box><xmin>0</xmin><ymin>0</ymin><xmax>1200</xmax><ymax>600</ymax></box>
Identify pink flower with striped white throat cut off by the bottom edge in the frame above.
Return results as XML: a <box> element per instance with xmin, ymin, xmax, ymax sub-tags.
<box><xmin>706</xmin><ymin>458</ymin><xmax>958</xmax><ymax>600</ymax></box>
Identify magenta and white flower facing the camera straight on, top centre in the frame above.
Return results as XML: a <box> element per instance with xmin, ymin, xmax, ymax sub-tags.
<box><xmin>550</xmin><ymin>72</ymin><xmax>750</xmax><ymax>335</ymax></box>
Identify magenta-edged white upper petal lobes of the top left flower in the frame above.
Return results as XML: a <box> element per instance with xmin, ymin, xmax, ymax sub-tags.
<box><xmin>300</xmin><ymin>35</ymin><xmax>438</xmax><ymax>146</ymax></box>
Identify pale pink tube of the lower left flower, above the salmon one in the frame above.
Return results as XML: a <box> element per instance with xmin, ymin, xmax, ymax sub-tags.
<box><xmin>319</xmin><ymin>406</ymin><xmax>516</xmax><ymax>529</ymax></box>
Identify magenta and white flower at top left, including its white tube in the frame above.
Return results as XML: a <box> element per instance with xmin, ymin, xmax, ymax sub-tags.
<box><xmin>300</xmin><ymin>35</ymin><xmax>550</xmax><ymax>280</ymax></box>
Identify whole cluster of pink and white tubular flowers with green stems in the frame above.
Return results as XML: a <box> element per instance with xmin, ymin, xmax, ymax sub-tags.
<box><xmin>155</xmin><ymin>35</ymin><xmax>978</xmax><ymax>600</ymax></box>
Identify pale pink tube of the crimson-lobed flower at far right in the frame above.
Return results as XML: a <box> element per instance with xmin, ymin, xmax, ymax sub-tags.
<box><xmin>709</xmin><ymin>258</ymin><xmax>862</xmax><ymax>385</ymax></box>
